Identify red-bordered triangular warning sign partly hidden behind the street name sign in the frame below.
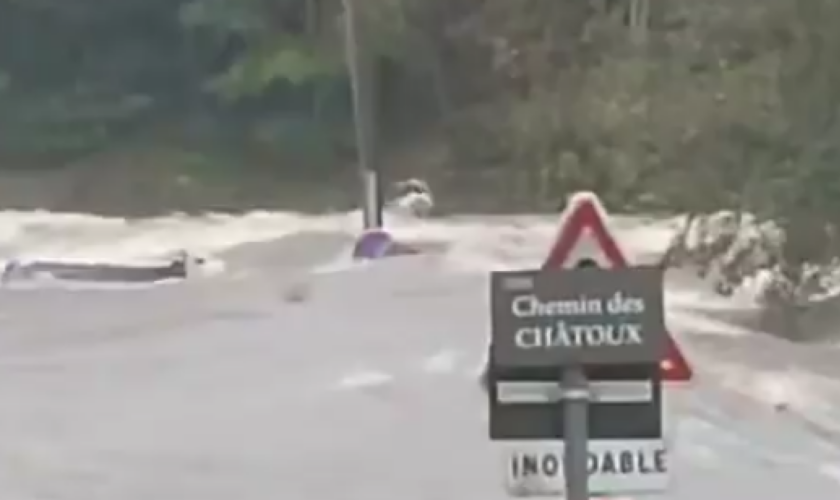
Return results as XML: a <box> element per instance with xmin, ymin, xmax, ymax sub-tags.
<box><xmin>543</xmin><ymin>192</ymin><xmax>693</xmax><ymax>382</ymax></box>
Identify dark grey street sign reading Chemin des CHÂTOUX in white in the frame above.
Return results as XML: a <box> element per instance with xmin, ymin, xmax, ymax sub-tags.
<box><xmin>491</xmin><ymin>266</ymin><xmax>667</xmax><ymax>368</ymax></box>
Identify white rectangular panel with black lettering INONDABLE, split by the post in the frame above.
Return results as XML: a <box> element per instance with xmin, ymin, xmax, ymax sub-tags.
<box><xmin>502</xmin><ymin>439</ymin><xmax>669</xmax><ymax>497</ymax></box>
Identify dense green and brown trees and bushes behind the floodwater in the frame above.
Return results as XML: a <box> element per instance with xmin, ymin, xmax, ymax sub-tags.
<box><xmin>0</xmin><ymin>0</ymin><xmax>840</xmax><ymax>221</ymax></box>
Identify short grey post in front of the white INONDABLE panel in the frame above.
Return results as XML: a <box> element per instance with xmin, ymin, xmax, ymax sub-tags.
<box><xmin>562</xmin><ymin>366</ymin><xmax>589</xmax><ymax>500</ymax></box>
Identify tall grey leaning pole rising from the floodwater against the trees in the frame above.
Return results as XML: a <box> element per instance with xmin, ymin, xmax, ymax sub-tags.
<box><xmin>343</xmin><ymin>0</ymin><xmax>382</xmax><ymax>229</ymax></box>
